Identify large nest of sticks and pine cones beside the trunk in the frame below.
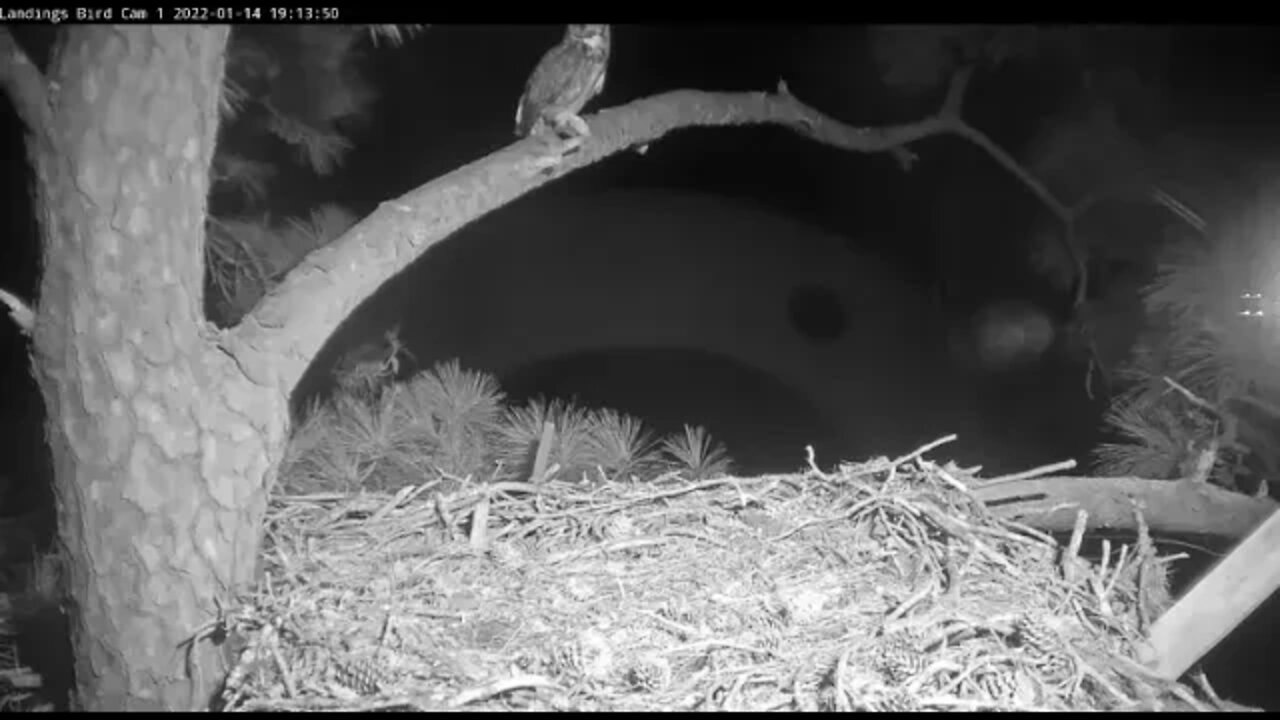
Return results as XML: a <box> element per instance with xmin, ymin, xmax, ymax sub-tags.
<box><xmin>211</xmin><ymin>451</ymin><xmax>1213</xmax><ymax>711</ymax></box>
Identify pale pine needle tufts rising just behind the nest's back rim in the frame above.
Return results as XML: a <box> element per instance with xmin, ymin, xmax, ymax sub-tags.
<box><xmin>279</xmin><ymin>353</ymin><xmax>732</xmax><ymax>493</ymax></box>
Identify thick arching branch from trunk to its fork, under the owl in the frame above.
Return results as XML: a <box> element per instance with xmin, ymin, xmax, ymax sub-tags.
<box><xmin>220</xmin><ymin>86</ymin><xmax>967</xmax><ymax>391</ymax></box>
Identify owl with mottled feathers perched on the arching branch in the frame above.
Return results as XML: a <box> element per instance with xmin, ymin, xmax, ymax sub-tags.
<box><xmin>516</xmin><ymin>24</ymin><xmax>609</xmax><ymax>137</ymax></box>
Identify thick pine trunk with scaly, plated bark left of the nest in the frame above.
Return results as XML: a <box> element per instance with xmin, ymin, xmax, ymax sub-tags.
<box><xmin>31</xmin><ymin>26</ymin><xmax>288</xmax><ymax>710</ymax></box>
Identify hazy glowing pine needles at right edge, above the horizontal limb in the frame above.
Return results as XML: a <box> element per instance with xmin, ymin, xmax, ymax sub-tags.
<box><xmin>1096</xmin><ymin>187</ymin><xmax>1280</xmax><ymax>493</ymax></box>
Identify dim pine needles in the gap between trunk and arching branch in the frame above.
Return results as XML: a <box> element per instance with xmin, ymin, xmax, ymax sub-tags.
<box><xmin>205</xmin><ymin>26</ymin><xmax>426</xmax><ymax>325</ymax></box>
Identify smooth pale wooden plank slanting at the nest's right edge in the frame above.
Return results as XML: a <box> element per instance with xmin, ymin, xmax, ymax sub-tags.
<box><xmin>1148</xmin><ymin>504</ymin><xmax>1280</xmax><ymax>680</ymax></box>
